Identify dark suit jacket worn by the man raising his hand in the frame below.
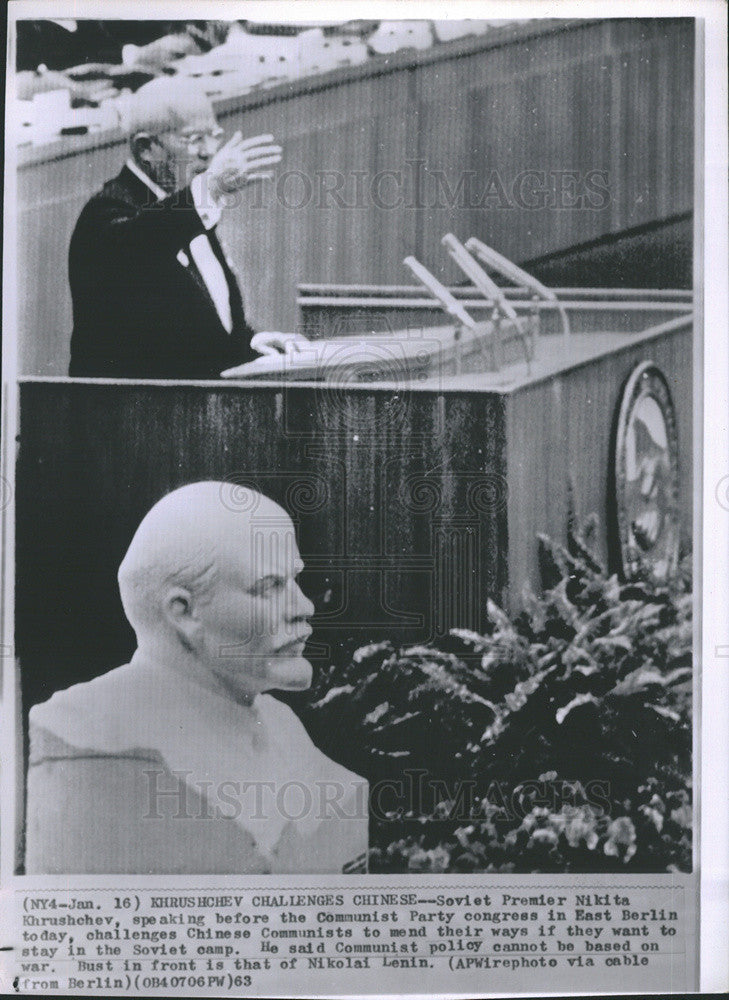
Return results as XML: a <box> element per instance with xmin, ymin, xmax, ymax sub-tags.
<box><xmin>69</xmin><ymin>167</ymin><xmax>257</xmax><ymax>379</ymax></box>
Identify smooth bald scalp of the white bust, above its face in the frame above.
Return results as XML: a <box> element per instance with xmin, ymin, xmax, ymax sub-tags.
<box><xmin>118</xmin><ymin>482</ymin><xmax>295</xmax><ymax>634</ymax></box>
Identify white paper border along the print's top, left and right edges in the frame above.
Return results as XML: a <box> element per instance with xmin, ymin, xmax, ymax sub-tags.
<box><xmin>0</xmin><ymin>0</ymin><xmax>729</xmax><ymax>992</ymax></box>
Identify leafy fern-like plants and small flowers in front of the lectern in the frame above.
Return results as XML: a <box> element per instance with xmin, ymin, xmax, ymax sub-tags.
<box><xmin>304</xmin><ymin>519</ymin><xmax>692</xmax><ymax>872</ymax></box>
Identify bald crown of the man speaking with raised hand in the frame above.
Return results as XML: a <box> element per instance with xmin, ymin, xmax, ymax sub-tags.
<box><xmin>119</xmin><ymin>76</ymin><xmax>215</xmax><ymax>139</ymax></box>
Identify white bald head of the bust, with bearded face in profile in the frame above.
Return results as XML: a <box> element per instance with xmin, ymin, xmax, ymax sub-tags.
<box><xmin>119</xmin><ymin>482</ymin><xmax>314</xmax><ymax>701</ymax></box>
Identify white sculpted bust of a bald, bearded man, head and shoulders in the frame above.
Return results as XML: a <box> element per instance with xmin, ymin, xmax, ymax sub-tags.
<box><xmin>26</xmin><ymin>482</ymin><xmax>368</xmax><ymax>874</ymax></box>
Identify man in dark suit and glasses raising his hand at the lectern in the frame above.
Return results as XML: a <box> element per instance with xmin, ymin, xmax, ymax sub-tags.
<box><xmin>69</xmin><ymin>77</ymin><xmax>294</xmax><ymax>379</ymax></box>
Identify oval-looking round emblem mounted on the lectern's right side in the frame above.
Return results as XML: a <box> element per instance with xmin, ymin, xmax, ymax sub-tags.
<box><xmin>615</xmin><ymin>361</ymin><xmax>679</xmax><ymax>579</ymax></box>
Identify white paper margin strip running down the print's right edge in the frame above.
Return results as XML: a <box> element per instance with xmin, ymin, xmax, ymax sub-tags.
<box><xmin>696</xmin><ymin>3</ymin><xmax>729</xmax><ymax>992</ymax></box>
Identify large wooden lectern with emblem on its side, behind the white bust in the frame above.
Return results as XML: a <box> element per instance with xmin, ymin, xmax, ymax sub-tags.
<box><xmin>17</xmin><ymin>245</ymin><xmax>693</xmax><ymax>703</ymax></box>
